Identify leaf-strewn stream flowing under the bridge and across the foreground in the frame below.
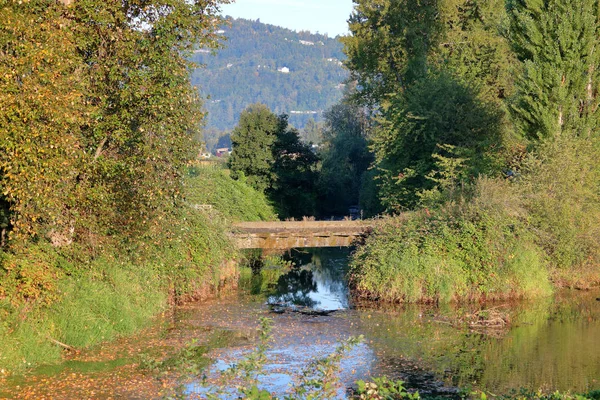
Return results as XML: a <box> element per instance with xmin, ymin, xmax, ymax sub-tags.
<box><xmin>0</xmin><ymin>249</ymin><xmax>600</xmax><ymax>398</ymax></box>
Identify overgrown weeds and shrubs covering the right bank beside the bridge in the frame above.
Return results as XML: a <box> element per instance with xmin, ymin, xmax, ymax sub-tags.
<box><xmin>350</xmin><ymin>138</ymin><xmax>600</xmax><ymax>302</ymax></box>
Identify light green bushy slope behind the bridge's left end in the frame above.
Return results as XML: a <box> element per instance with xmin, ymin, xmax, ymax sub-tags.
<box><xmin>185</xmin><ymin>167</ymin><xmax>277</xmax><ymax>221</ymax></box>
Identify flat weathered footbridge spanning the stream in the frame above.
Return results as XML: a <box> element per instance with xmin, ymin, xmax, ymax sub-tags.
<box><xmin>232</xmin><ymin>220</ymin><xmax>373</xmax><ymax>249</ymax></box>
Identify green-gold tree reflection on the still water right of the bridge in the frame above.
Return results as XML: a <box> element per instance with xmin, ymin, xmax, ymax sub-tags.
<box><xmin>361</xmin><ymin>293</ymin><xmax>600</xmax><ymax>393</ymax></box>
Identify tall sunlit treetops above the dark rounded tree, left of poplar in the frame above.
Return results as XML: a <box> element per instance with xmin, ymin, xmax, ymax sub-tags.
<box><xmin>342</xmin><ymin>0</ymin><xmax>514</xmax><ymax>106</ymax></box>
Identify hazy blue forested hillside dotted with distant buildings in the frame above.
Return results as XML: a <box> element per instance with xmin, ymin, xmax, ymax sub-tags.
<box><xmin>191</xmin><ymin>18</ymin><xmax>348</xmax><ymax>130</ymax></box>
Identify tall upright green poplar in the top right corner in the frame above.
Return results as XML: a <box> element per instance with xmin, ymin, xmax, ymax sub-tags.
<box><xmin>508</xmin><ymin>0</ymin><xmax>600</xmax><ymax>140</ymax></box>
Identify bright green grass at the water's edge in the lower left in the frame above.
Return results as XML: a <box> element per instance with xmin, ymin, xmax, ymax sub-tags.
<box><xmin>0</xmin><ymin>252</ymin><xmax>167</xmax><ymax>372</ymax></box>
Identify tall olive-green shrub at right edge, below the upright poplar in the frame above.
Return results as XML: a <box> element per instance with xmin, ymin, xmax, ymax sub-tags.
<box><xmin>519</xmin><ymin>137</ymin><xmax>600</xmax><ymax>287</ymax></box>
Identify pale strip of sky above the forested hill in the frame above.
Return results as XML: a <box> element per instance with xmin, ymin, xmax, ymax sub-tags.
<box><xmin>222</xmin><ymin>0</ymin><xmax>352</xmax><ymax>37</ymax></box>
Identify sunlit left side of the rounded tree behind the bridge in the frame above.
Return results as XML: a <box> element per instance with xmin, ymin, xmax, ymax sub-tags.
<box><xmin>229</xmin><ymin>103</ymin><xmax>280</xmax><ymax>192</ymax></box>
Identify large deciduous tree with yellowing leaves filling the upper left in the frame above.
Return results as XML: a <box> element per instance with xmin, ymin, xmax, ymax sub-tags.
<box><xmin>0</xmin><ymin>0</ymin><xmax>227</xmax><ymax>245</ymax></box>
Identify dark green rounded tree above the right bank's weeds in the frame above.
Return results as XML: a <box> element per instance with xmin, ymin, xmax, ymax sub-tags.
<box><xmin>372</xmin><ymin>73</ymin><xmax>502</xmax><ymax>211</ymax></box>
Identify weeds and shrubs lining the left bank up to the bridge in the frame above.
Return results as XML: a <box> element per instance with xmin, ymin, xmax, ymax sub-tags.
<box><xmin>0</xmin><ymin>168</ymin><xmax>274</xmax><ymax>372</ymax></box>
